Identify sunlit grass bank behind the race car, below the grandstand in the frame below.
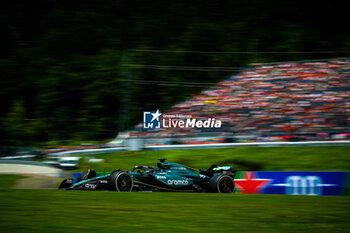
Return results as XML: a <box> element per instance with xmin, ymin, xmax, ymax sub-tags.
<box><xmin>76</xmin><ymin>146</ymin><xmax>350</xmax><ymax>171</ymax></box>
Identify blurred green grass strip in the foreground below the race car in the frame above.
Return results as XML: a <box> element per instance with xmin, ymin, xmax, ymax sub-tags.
<box><xmin>0</xmin><ymin>190</ymin><xmax>350</xmax><ymax>233</ymax></box>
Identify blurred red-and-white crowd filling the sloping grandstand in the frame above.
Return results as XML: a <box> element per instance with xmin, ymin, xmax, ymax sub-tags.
<box><xmin>138</xmin><ymin>59</ymin><xmax>350</xmax><ymax>141</ymax></box>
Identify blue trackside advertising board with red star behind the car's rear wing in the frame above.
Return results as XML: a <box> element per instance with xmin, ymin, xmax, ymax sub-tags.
<box><xmin>72</xmin><ymin>171</ymin><xmax>350</xmax><ymax>195</ymax></box>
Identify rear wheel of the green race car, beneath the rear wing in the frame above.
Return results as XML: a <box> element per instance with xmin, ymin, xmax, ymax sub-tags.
<box><xmin>208</xmin><ymin>174</ymin><xmax>235</xmax><ymax>193</ymax></box>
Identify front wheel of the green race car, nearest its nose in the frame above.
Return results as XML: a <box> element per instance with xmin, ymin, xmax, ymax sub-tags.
<box><xmin>109</xmin><ymin>171</ymin><xmax>134</xmax><ymax>192</ymax></box>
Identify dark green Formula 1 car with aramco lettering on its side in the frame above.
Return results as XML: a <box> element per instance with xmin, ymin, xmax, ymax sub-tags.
<box><xmin>59</xmin><ymin>159</ymin><xmax>236</xmax><ymax>193</ymax></box>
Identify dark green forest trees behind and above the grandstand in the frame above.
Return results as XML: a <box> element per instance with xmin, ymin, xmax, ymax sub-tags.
<box><xmin>0</xmin><ymin>0</ymin><xmax>350</xmax><ymax>145</ymax></box>
